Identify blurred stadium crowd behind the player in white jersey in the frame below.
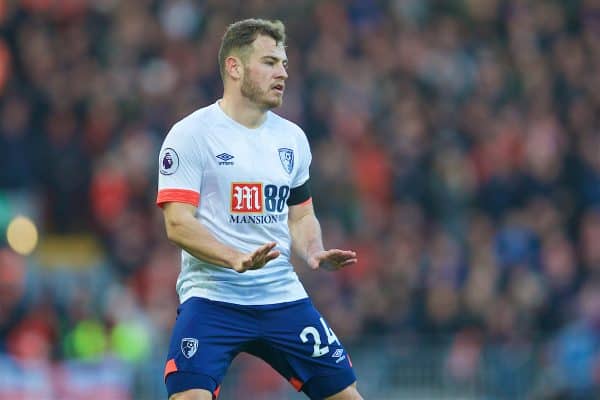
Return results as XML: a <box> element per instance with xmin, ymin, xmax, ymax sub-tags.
<box><xmin>0</xmin><ymin>0</ymin><xmax>600</xmax><ymax>400</ymax></box>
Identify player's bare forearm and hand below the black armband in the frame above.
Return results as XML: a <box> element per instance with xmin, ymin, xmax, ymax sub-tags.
<box><xmin>288</xmin><ymin>202</ymin><xmax>358</xmax><ymax>270</ymax></box>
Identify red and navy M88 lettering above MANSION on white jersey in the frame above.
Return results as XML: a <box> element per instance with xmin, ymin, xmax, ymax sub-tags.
<box><xmin>231</xmin><ymin>182</ymin><xmax>290</xmax><ymax>214</ymax></box>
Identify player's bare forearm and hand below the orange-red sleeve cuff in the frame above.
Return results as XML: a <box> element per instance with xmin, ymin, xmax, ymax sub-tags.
<box><xmin>163</xmin><ymin>202</ymin><xmax>280</xmax><ymax>272</ymax></box>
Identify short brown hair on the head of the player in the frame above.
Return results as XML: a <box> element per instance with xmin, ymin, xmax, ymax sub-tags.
<box><xmin>219</xmin><ymin>18</ymin><xmax>285</xmax><ymax>80</ymax></box>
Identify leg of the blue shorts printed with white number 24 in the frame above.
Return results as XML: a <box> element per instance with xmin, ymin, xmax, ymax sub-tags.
<box><xmin>257</xmin><ymin>299</ymin><xmax>356</xmax><ymax>399</ymax></box>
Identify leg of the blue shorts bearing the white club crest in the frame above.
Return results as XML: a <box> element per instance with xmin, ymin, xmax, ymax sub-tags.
<box><xmin>165</xmin><ymin>297</ymin><xmax>257</xmax><ymax>397</ymax></box>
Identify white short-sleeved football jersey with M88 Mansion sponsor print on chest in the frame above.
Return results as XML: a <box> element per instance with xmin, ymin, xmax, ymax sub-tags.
<box><xmin>157</xmin><ymin>102</ymin><xmax>311</xmax><ymax>305</ymax></box>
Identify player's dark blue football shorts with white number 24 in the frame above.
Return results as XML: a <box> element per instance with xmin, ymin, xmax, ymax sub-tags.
<box><xmin>165</xmin><ymin>297</ymin><xmax>356</xmax><ymax>399</ymax></box>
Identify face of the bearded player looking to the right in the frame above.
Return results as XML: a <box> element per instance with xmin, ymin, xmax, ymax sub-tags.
<box><xmin>241</xmin><ymin>36</ymin><xmax>288</xmax><ymax>109</ymax></box>
